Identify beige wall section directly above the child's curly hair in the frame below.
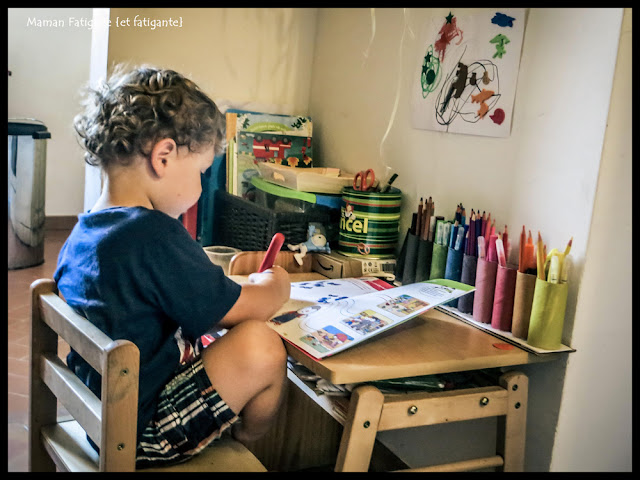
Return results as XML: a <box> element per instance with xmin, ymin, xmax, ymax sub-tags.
<box><xmin>109</xmin><ymin>8</ymin><xmax>317</xmax><ymax>114</ymax></box>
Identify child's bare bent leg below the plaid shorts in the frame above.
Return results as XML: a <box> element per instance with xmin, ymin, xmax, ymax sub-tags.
<box><xmin>202</xmin><ymin>321</ymin><xmax>287</xmax><ymax>442</ymax></box>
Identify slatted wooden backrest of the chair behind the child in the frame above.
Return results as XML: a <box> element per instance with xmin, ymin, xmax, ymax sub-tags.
<box><xmin>29</xmin><ymin>279</ymin><xmax>140</xmax><ymax>471</ymax></box>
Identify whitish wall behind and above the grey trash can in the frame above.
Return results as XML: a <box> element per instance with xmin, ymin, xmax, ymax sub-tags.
<box><xmin>7</xmin><ymin>8</ymin><xmax>92</xmax><ymax>216</ymax></box>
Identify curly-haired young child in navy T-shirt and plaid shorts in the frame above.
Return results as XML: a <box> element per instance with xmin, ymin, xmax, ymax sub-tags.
<box><xmin>54</xmin><ymin>67</ymin><xmax>290</xmax><ymax>468</ymax></box>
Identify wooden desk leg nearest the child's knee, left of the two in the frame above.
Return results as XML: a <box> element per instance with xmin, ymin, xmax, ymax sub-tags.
<box><xmin>335</xmin><ymin>385</ymin><xmax>384</xmax><ymax>472</ymax></box>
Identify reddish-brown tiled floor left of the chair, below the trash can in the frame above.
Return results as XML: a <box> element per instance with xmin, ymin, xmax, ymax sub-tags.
<box><xmin>7</xmin><ymin>230</ymin><xmax>69</xmax><ymax>472</ymax></box>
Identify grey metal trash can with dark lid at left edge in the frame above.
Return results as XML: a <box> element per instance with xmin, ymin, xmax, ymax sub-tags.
<box><xmin>7</xmin><ymin>118</ymin><xmax>51</xmax><ymax>270</ymax></box>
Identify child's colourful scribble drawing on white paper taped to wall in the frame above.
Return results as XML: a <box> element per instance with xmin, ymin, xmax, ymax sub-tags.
<box><xmin>411</xmin><ymin>8</ymin><xmax>525</xmax><ymax>137</ymax></box>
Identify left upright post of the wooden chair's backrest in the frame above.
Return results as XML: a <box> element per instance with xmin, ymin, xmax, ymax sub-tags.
<box><xmin>28</xmin><ymin>280</ymin><xmax>58</xmax><ymax>472</ymax></box>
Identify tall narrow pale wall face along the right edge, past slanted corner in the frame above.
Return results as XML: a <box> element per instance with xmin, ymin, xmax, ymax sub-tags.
<box><xmin>551</xmin><ymin>8</ymin><xmax>633</xmax><ymax>472</ymax></box>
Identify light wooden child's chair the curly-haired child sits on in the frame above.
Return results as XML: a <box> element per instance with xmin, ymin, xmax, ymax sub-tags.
<box><xmin>29</xmin><ymin>279</ymin><xmax>266</xmax><ymax>472</ymax></box>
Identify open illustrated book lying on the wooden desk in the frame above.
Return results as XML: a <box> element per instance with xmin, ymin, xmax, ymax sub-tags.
<box><xmin>268</xmin><ymin>277</ymin><xmax>474</xmax><ymax>359</ymax></box>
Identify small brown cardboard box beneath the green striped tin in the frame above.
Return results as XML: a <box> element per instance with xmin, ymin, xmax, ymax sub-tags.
<box><xmin>311</xmin><ymin>252</ymin><xmax>396</xmax><ymax>280</ymax></box>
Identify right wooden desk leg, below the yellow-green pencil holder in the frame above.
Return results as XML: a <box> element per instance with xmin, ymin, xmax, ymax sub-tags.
<box><xmin>497</xmin><ymin>372</ymin><xmax>529</xmax><ymax>472</ymax></box>
